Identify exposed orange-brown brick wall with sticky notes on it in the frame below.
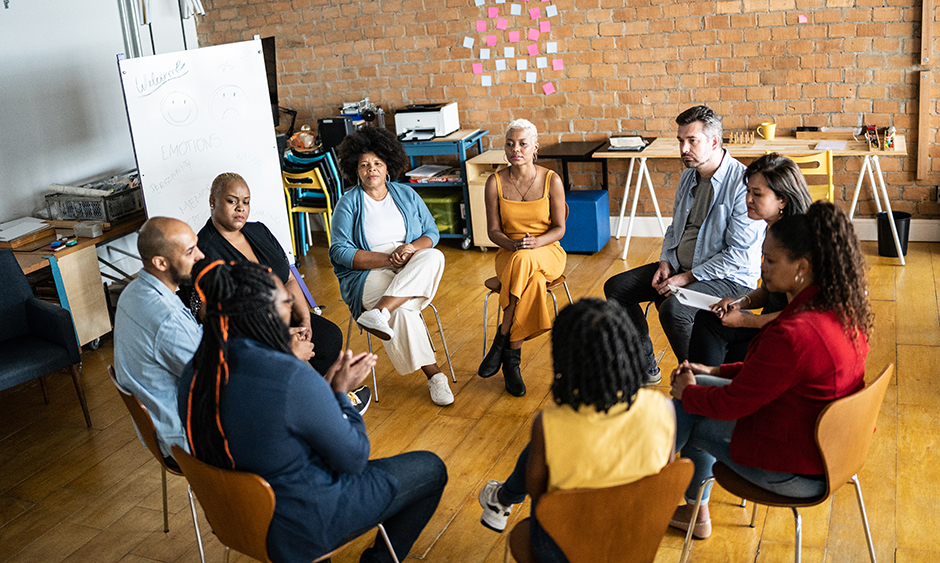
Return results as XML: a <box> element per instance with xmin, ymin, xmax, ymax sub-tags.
<box><xmin>198</xmin><ymin>0</ymin><xmax>940</xmax><ymax>218</ymax></box>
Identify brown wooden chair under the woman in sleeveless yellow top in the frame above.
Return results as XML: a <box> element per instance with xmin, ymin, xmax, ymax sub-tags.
<box><xmin>506</xmin><ymin>459</ymin><xmax>693</xmax><ymax>563</ymax></box>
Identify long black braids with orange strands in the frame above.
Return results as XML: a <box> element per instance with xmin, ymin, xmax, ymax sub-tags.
<box><xmin>184</xmin><ymin>260</ymin><xmax>291</xmax><ymax>469</ymax></box>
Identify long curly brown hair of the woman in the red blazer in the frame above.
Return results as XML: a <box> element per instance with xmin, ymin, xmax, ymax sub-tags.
<box><xmin>770</xmin><ymin>200</ymin><xmax>874</xmax><ymax>342</ymax></box>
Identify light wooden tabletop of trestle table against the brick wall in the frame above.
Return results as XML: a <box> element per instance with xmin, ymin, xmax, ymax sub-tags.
<box><xmin>594</xmin><ymin>135</ymin><xmax>907</xmax><ymax>158</ymax></box>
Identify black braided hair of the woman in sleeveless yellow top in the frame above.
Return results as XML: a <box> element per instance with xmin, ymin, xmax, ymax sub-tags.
<box><xmin>552</xmin><ymin>299</ymin><xmax>646</xmax><ymax>412</ymax></box>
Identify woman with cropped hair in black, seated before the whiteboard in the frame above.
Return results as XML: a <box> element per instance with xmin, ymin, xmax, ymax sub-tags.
<box><xmin>196</xmin><ymin>172</ymin><xmax>371</xmax><ymax>413</ymax></box>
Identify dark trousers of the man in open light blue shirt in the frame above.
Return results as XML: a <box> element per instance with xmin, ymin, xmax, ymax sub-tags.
<box><xmin>604</xmin><ymin>262</ymin><xmax>750</xmax><ymax>373</ymax></box>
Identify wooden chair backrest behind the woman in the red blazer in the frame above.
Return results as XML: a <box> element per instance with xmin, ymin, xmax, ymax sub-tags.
<box><xmin>816</xmin><ymin>364</ymin><xmax>894</xmax><ymax>496</ymax></box>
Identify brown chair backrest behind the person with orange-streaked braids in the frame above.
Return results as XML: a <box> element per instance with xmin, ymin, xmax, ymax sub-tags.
<box><xmin>173</xmin><ymin>446</ymin><xmax>274</xmax><ymax>563</ymax></box>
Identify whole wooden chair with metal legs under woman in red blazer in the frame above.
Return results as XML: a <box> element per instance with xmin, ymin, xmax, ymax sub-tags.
<box><xmin>680</xmin><ymin>364</ymin><xmax>894</xmax><ymax>563</ymax></box>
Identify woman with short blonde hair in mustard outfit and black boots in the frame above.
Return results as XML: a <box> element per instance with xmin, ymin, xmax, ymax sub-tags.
<box><xmin>478</xmin><ymin>119</ymin><xmax>566</xmax><ymax>397</ymax></box>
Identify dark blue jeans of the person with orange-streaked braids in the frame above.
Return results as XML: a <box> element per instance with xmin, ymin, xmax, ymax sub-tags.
<box><xmin>344</xmin><ymin>451</ymin><xmax>447</xmax><ymax>563</ymax></box>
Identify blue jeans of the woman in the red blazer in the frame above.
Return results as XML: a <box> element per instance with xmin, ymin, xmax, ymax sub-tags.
<box><xmin>673</xmin><ymin>375</ymin><xmax>826</xmax><ymax>504</ymax></box>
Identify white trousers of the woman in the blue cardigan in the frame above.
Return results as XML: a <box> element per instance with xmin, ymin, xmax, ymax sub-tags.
<box><xmin>362</xmin><ymin>244</ymin><xmax>444</xmax><ymax>374</ymax></box>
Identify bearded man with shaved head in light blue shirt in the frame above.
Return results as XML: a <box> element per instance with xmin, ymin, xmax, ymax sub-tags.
<box><xmin>114</xmin><ymin>217</ymin><xmax>203</xmax><ymax>467</ymax></box>
